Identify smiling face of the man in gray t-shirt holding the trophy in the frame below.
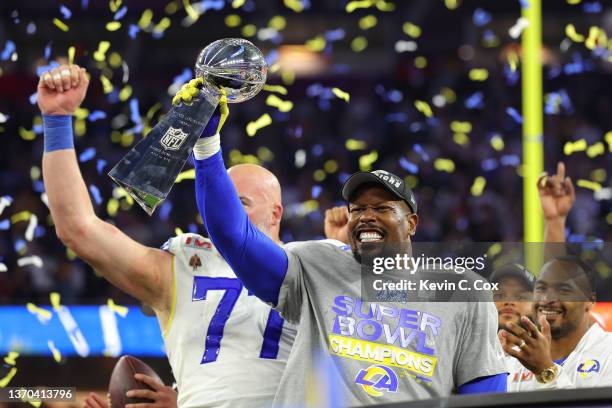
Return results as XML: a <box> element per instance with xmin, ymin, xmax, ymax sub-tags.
<box><xmin>348</xmin><ymin>184</ymin><xmax>418</xmax><ymax>262</ymax></box>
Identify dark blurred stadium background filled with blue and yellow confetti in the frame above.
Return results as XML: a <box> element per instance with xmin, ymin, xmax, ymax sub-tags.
<box><xmin>0</xmin><ymin>0</ymin><xmax>612</xmax><ymax>406</ymax></box>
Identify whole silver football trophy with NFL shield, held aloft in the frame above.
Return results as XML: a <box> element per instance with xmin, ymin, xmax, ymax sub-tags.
<box><xmin>108</xmin><ymin>38</ymin><xmax>268</xmax><ymax>215</ymax></box>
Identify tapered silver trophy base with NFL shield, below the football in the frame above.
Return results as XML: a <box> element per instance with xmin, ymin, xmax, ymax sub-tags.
<box><xmin>108</xmin><ymin>85</ymin><xmax>221</xmax><ymax>215</ymax></box>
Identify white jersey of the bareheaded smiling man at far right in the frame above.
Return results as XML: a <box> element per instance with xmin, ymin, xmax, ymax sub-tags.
<box><xmin>506</xmin><ymin>323</ymin><xmax>612</xmax><ymax>392</ymax></box>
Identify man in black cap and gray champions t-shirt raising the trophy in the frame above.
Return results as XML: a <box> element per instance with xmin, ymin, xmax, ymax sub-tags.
<box><xmin>195</xmin><ymin>122</ymin><xmax>507</xmax><ymax>407</ymax></box>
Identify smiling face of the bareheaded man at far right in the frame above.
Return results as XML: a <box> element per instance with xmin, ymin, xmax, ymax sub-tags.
<box><xmin>533</xmin><ymin>260</ymin><xmax>594</xmax><ymax>339</ymax></box>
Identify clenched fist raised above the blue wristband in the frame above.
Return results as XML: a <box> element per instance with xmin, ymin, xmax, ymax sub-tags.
<box><xmin>38</xmin><ymin>65</ymin><xmax>89</xmax><ymax>115</ymax></box>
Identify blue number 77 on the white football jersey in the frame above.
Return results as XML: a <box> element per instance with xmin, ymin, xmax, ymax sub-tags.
<box><xmin>191</xmin><ymin>276</ymin><xmax>284</xmax><ymax>364</ymax></box>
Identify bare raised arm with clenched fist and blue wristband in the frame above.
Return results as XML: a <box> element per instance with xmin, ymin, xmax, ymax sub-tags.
<box><xmin>38</xmin><ymin>65</ymin><xmax>172</xmax><ymax>313</ymax></box>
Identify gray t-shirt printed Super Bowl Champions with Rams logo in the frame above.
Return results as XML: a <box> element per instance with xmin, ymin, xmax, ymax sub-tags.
<box><xmin>275</xmin><ymin>240</ymin><xmax>507</xmax><ymax>407</ymax></box>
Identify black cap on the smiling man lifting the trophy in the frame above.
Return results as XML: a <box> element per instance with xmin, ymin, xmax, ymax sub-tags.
<box><xmin>342</xmin><ymin>170</ymin><xmax>417</xmax><ymax>214</ymax></box>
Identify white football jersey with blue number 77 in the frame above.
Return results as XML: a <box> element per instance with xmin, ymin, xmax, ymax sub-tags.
<box><xmin>162</xmin><ymin>234</ymin><xmax>296</xmax><ymax>408</ymax></box>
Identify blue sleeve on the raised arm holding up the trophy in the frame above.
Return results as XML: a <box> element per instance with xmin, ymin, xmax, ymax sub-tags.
<box><xmin>194</xmin><ymin>151</ymin><xmax>289</xmax><ymax>305</ymax></box>
